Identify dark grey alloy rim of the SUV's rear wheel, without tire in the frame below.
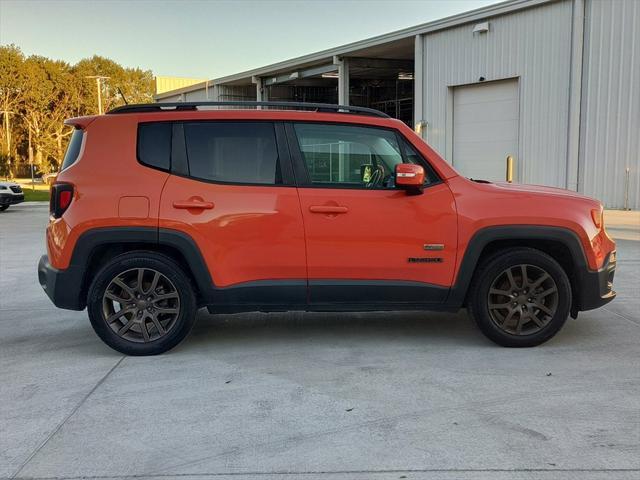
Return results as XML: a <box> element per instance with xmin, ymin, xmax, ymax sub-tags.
<box><xmin>102</xmin><ymin>268</ymin><xmax>180</xmax><ymax>343</ymax></box>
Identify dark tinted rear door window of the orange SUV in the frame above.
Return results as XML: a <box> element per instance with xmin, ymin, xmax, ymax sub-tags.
<box><xmin>184</xmin><ymin>122</ymin><xmax>282</xmax><ymax>185</ymax></box>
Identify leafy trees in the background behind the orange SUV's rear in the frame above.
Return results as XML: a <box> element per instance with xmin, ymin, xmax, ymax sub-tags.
<box><xmin>0</xmin><ymin>45</ymin><xmax>153</xmax><ymax>176</ymax></box>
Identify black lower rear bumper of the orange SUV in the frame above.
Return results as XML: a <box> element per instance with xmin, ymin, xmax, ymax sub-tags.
<box><xmin>38</xmin><ymin>255</ymin><xmax>86</xmax><ymax>310</ymax></box>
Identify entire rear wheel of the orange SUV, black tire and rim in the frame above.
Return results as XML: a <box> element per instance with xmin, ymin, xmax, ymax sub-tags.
<box><xmin>87</xmin><ymin>251</ymin><xmax>197</xmax><ymax>356</ymax></box>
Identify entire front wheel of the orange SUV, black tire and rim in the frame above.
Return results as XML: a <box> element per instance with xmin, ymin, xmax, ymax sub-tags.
<box><xmin>467</xmin><ymin>247</ymin><xmax>571</xmax><ymax>347</ymax></box>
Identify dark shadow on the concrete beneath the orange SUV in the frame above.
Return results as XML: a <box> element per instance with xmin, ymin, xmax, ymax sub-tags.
<box><xmin>14</xmin><ymin>309</ymin><xmax>610</xmax><ymax>357</ymax></box>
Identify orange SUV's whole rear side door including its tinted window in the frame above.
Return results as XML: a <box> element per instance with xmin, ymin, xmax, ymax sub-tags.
<box><xmin>160</xmin><ymin>121</ymin><xmax>306</xmax><ymax>309</ymax></box>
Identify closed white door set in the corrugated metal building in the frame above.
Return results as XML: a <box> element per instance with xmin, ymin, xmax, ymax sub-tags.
<box><xmin>453</xmin><ymin>79</ymin><xmax>522</xmax><ymax>182</ymax></box>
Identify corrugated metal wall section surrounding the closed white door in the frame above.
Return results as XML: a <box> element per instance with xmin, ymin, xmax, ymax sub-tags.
<box><xmin>423</xmin><ymin>0</ymin><xmax>572</xmax><ymax>187</ymax></box>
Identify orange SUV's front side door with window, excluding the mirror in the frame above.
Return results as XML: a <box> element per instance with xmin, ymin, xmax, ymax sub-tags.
<box><xmin>287</xmin><ymin>123</ymin><xmax>456</xmax><ymax>308</ymax></box>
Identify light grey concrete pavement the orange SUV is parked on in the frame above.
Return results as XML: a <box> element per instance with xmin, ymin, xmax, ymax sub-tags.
<box><xmin>0</xmin><ymin>204</ymin><xmax>640</xmax><ymax>480</ymax></box>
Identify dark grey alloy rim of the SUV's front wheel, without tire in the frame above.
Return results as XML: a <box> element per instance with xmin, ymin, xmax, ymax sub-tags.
<box><xmin>487</xmin><ymin>264</ymin><xmax>559</xmax><ymax>335</ymax></box>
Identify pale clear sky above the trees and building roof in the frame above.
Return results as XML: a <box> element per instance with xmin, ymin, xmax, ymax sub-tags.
<box><xmin>0</xmin><ymin>0</ymin><xmax>498</xmax><ymax>79</ymax></box>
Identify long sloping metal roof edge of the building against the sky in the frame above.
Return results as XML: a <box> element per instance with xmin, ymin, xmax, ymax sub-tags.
<box><xmin>155</xmin><ymin>0</ymin><xmax>558</xmax><ymax>99</ymax></box>
